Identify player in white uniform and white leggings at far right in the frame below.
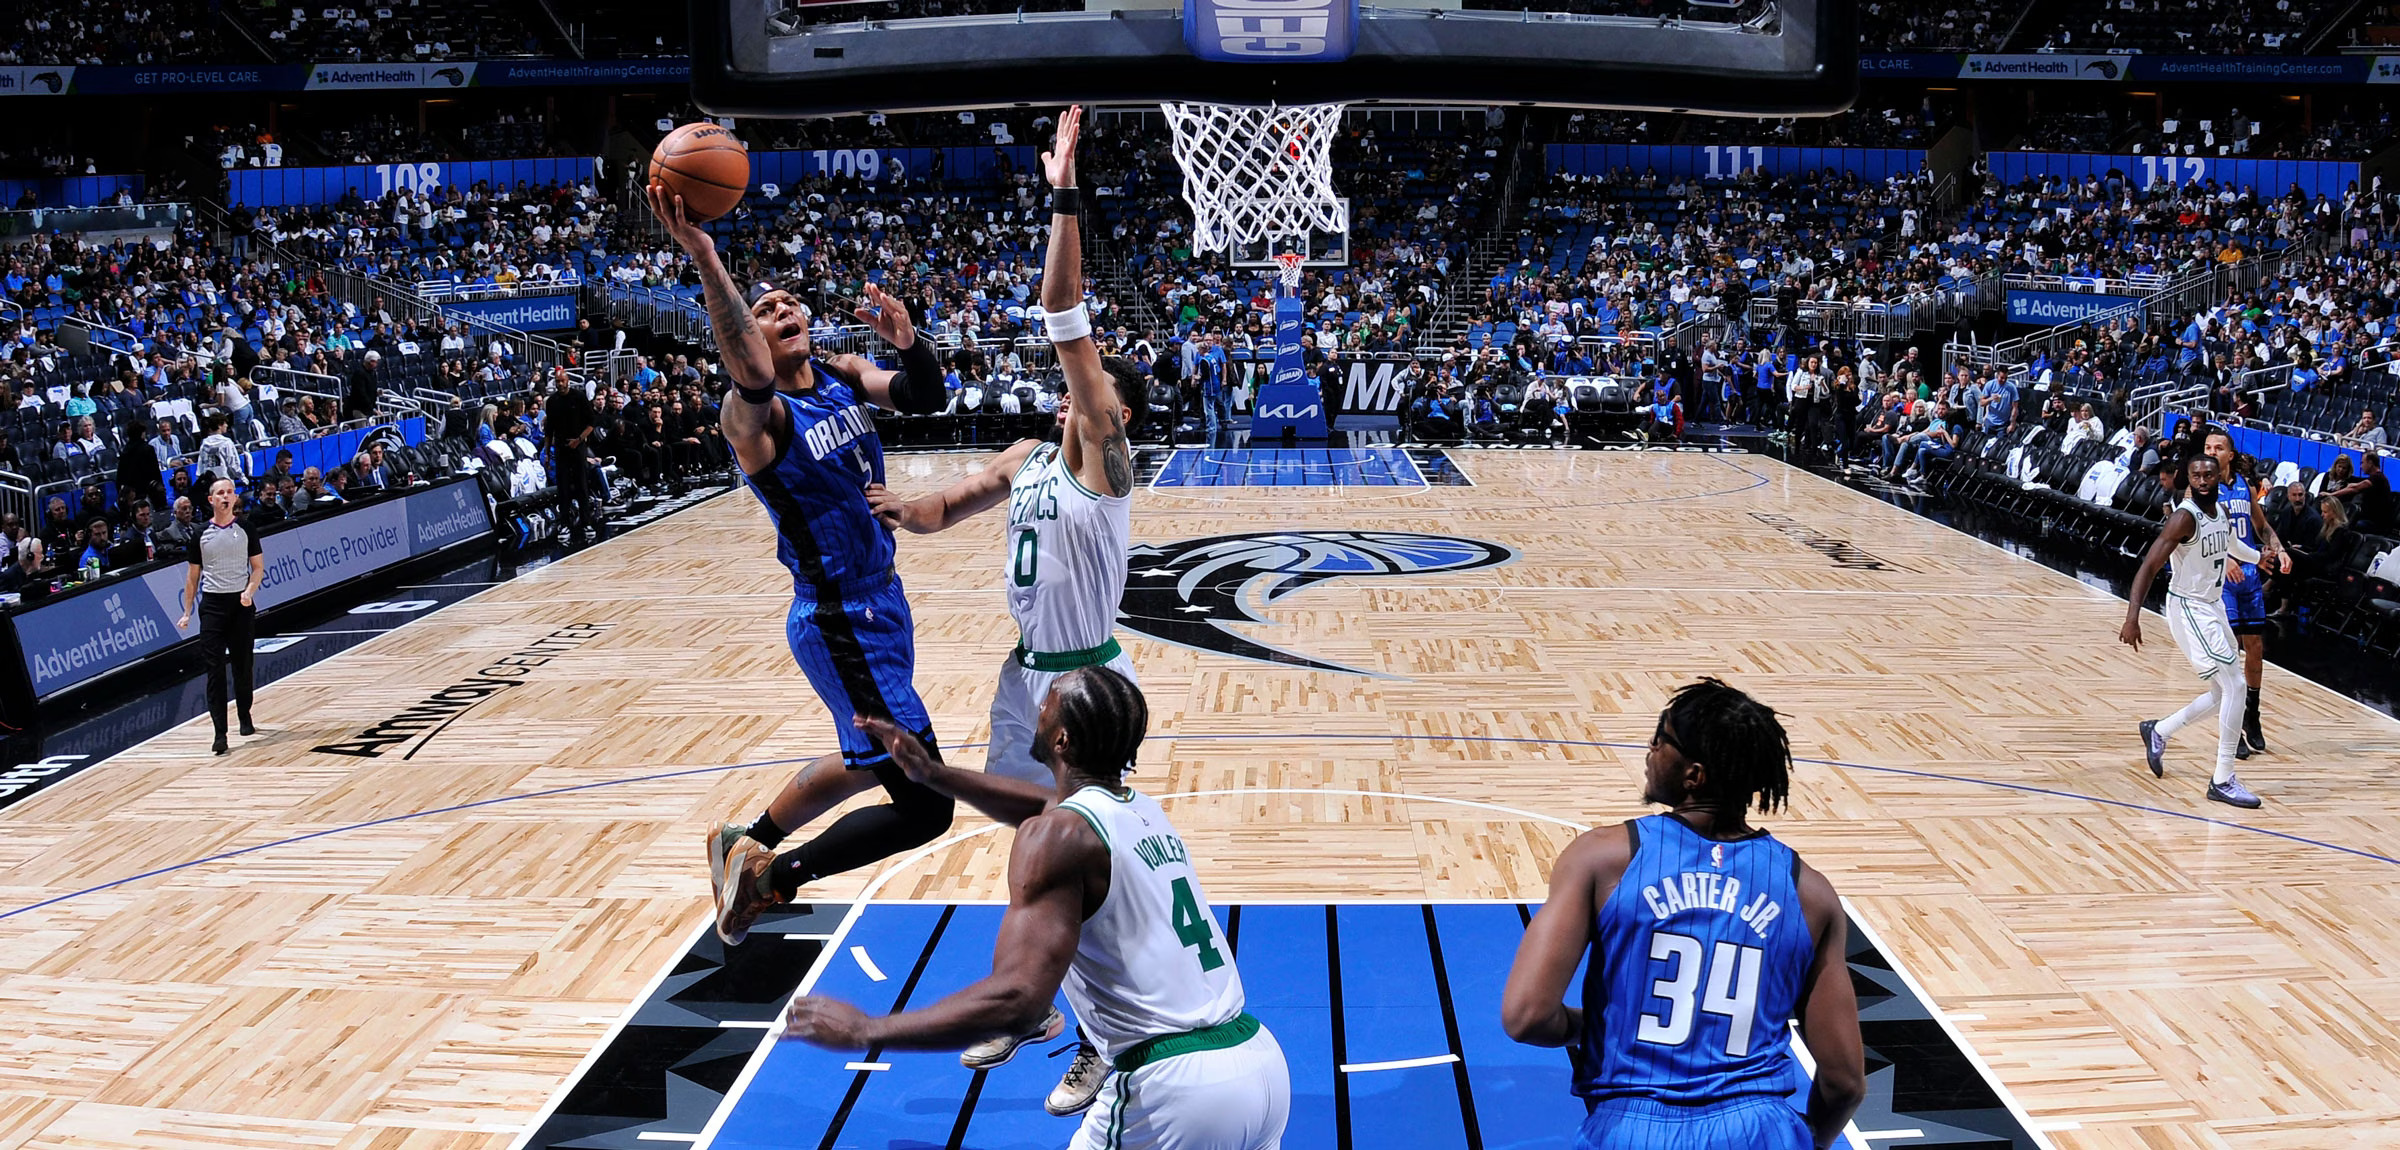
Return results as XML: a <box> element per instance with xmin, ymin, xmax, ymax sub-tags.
<box><xmin>2117</xmin><ymin>454</ymin><xmax>2258</xmax><ymax>809</ymax></box>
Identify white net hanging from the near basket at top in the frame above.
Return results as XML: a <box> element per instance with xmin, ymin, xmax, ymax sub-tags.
<box><xmin>1159</xmin><ymin>103</ymin><xmax>1349</xmax><ymax>252</ymax></box>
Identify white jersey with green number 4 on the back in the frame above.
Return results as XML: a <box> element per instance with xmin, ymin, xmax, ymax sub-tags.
<box><xmin>1061</xmin><ymin>787</ymin><xmax>1243</xmax><ymax>1059</ymax></box>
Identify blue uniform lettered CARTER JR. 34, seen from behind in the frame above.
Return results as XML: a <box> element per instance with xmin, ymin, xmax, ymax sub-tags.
<box><xmin>1570</xmin><ymin>814</ymin><xmax>1814</xmax><ymax>1150</ymax></box>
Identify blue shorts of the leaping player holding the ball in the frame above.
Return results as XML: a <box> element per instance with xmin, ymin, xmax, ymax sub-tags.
<box><xmin>785</xmin><ymin>576</ymin><xmax>934</xmax><ymax>771</ymax></box>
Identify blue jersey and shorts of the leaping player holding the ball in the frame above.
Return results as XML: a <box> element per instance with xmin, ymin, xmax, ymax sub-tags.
<box><xmin>744</xmin><ymin>363</ymin><xmax>934</xmax><ymax>768</ymax></box>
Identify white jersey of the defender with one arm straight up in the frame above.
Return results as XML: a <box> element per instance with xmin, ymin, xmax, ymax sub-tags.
<box><xmin>1008</xmin><ymin>444</ymin><xmax>1133</xmax><ymax>653</ymax></box>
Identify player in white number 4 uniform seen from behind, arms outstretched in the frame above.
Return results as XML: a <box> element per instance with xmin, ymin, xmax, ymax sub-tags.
<box><xmin>785</xmin><ymin>667</ymin><xmax>1296</xmax><ymax>1150</ymax></box>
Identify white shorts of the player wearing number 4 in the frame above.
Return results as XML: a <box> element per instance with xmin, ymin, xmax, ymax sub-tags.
<box><xmin>1068</xmin><ymin>1028</ymin><xmax>1291</xmax><ymax>1150</ymax></box>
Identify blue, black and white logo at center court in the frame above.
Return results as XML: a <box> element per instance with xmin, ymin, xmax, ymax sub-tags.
<box><xmin>1116</xmin><ymin>531</ymin><xmax>1517</xmax><ymax>675</ymax></box>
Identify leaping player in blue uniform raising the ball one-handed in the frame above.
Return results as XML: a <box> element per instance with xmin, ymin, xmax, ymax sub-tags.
<box><xmin>650</xmin><ymin>185</ymin><xmax>953</xmax><ymax>946</ymax></box>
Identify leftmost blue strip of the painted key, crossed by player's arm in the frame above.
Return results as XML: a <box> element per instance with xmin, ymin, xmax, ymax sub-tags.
<box><xmin>715</xmin><ymin>905</ymin><xmax>958</xmax><ymax>1150</ymax></box>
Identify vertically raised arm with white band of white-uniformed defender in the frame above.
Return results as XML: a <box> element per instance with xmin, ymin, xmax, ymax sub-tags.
<box><xmin>1042</xmin><ymin>106</ymin><xmax>1140</xmax><ymax>495</ymax></box>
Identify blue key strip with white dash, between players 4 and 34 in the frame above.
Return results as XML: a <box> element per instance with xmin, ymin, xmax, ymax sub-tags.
<box><xmin>1334</xmin><ymin>903</ymin><xmax>1466</xmax><ymax>1148</ymax></box>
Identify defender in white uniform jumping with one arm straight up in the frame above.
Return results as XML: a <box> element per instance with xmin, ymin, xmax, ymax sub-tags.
<box><xmin>866</xmin><ymin>108</ymin><xmax>1150</xmax><ymax>1116</ymax></box>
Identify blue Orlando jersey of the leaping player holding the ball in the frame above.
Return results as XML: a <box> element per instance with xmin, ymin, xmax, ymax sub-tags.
<box><xmin>727</xmin><ymin>363</ymin><xmax>893</xmax><ymax>598</ymax></box>
